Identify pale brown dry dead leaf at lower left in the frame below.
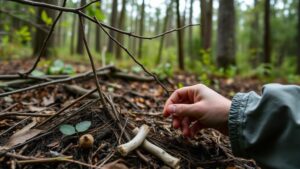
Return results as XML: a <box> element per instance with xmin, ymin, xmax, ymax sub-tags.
<box><xmin>5</xmin><ymin>121</ymin><xmax>43</xmax><ymax>148</ymax></box>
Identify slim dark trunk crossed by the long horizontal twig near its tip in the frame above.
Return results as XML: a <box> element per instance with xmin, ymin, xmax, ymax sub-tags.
<box><xmin>176</xmin><ymin>0</ymin><xmax>184</xmax><ymax>70</ymax></box>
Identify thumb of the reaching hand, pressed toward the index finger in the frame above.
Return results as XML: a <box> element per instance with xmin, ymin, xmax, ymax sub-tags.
<box><xmin>167</xmin><ymin>103</ymin><xmax>200</xmax><ymax>117</ymax></box>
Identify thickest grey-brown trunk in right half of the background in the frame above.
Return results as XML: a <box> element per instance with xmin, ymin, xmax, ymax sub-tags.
<box><xmin>217</xmin><ymin>0</ymin><xmax>235</xmax><ymax>68</ymax></box>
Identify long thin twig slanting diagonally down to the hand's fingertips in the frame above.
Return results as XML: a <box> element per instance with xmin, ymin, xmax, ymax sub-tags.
<box><xmin>95</xmin><ymin>17</ymin><xmax>170</xmax><ymax>95</ymax></box>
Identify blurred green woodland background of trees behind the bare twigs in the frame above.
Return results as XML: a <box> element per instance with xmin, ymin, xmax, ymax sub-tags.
<box><xmin>0</xmin><ymin>0</ymin><xmax>300</xmax><ymax>74</ymax></box>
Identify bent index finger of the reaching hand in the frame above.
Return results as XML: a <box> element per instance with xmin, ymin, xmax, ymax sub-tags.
<box><xmin>163</xmin><ymin>87</ymin><xmax>190</xmax><ymax>117</ymax></box>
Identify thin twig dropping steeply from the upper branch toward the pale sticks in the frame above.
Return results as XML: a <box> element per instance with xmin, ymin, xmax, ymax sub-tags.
<box><xmin>78</xmin><ymin>15</ymin><xmax>107</xmax><ymax>109</ymax></box>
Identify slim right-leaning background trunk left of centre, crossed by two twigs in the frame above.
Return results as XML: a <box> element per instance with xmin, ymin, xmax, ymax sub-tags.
<box><xmin>116</xmin><ymin>0</ymin><xmax>127</xmax><ymax>59</ymax></box>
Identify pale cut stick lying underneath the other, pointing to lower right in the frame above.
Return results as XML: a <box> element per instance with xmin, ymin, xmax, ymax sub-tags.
<box><xmin>133</xmin><ymin>128</ymin><xmax>180</xmax><ymax>168</ymax></box>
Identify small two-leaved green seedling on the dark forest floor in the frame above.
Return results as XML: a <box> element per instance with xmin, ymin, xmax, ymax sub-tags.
<box><xmin>59</xmin><ymin>121</ymin><xmax>92</xmax><ymax>136</ymax></box>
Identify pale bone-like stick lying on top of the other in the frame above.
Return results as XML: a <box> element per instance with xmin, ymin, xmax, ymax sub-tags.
<box><xmin>117</xmin><ymin>124</ymin><xmax>149</xmax><ymax>156</ymax></box>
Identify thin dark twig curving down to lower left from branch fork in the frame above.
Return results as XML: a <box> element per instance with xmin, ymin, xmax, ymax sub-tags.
<box><xmin>19</xmin><ymin>0</ymin><xmax>67</xmax><ymax>76</ymax></box>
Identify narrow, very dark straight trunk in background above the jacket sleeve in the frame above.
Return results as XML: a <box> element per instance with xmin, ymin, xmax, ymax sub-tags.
<box><xmin>264</xmin><ymin>0</ymin><xmax>271</xmax><ymax>64</ymax></box>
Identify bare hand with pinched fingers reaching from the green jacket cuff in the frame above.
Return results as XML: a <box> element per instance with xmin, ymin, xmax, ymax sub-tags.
<box><xmin>163</xmin><ymin>84</ymin><xmax>231</xmax><ymax>137</ymax></box>
